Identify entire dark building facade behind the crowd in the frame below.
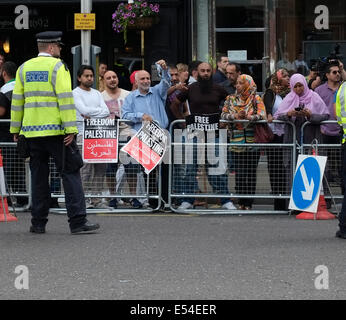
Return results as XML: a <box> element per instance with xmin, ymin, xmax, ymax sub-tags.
<box><xmin>0</xmin><ymin>0</ymin><xmax>346</xmax><ymax>90</ymax></box>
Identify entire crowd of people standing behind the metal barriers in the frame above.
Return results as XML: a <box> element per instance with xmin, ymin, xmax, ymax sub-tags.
<box><xmin>0</xmin><ymin>32</ymin><xmax>346</xmax><ymax>238</ymax></box>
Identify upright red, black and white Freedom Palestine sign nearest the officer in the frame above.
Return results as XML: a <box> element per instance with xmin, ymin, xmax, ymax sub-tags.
<box><xmin>83</xmin><ymin>118</ymin><xmax>118</xmax><ymax>163</ymax></box>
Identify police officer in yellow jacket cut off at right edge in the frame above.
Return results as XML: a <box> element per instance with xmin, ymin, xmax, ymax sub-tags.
<box><xmin>335</xmin><ymin>82</ymin><xmax>346</xmax><ymax>239</ymax></box>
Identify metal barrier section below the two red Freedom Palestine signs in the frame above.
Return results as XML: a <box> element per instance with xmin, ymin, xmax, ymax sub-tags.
<box><xmin>50</xmin><ymin>119</ymin><xmax>162</xmax><ymax>213</ymax></box>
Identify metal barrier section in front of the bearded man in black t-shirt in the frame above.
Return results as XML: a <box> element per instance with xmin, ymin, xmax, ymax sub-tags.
<box><xmin>168</xmin><ymin>120</ymin><xmax>296</xmax><ymax>214</ymax></box>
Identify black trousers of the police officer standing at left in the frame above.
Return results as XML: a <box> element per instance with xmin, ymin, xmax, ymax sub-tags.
<box><xmin>27</xmin><ymin>135</ymin><xmax>87</xmax><ymax>228</ymax></box>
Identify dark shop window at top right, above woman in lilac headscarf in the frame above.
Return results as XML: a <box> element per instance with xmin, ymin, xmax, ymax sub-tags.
<box><xmin>276</xmin><ymin>0</ymin><xmax>346</xmax><ymax>67</ymax></box>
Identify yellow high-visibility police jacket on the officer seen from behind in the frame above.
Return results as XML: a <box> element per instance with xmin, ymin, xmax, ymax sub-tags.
<box><xmin>10</xmin><ymin>56</ymin><xmax>78</xmax><ymax>138</ymax></box>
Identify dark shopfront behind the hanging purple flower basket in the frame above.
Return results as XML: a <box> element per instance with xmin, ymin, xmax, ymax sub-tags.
<box><xmin>0</xmin><ymin>0</ymin><xmax>191</xmax><ymax>89</ymax></box>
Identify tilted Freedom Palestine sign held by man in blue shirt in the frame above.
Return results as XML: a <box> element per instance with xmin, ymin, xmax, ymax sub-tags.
<box><xmin>121</xmin><ymin>122</ymin><xmax>167</xmax><ymax>174</ymax></box>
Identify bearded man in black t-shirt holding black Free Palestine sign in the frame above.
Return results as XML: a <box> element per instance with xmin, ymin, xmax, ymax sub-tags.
<box><xmin>171</xmin><ymin>62</ymin><xmax>235</xmax><ymax>210</ymax></box>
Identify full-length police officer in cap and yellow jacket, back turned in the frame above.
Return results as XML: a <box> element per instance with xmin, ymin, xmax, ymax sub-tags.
<box><xmin>10</xmin><ymin>31</ymin><xmax>100</xmax><ymax>233</ymax></box>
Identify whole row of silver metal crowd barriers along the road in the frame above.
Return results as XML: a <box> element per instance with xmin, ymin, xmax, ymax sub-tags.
<box><xmin>0</xmin><ymin>120</ymin><xmax>343</xmax><ymax>215</ymax></box>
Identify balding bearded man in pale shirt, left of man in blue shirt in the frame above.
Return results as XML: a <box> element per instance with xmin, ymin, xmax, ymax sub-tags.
<box><xmin>101</xmin><ymin>70</ymin><xmax>142</xmax><ymax>209</ymax></box>
